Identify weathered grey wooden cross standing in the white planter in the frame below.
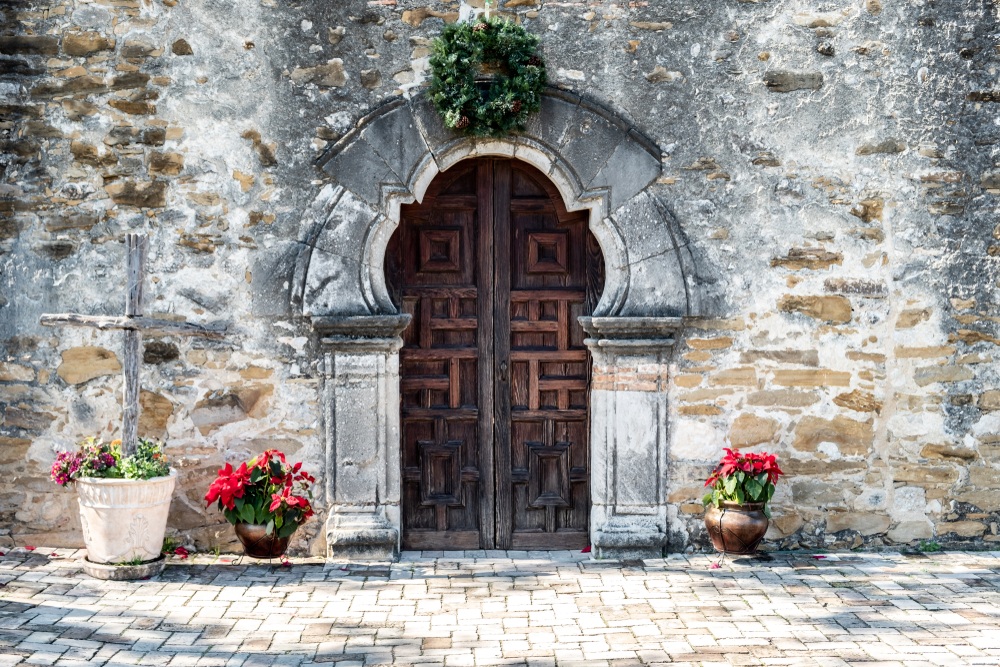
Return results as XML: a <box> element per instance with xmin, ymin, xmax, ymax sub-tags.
<box><xmin>41</xmin><ymin>234</ymin><xmax>225</xmax><ymax>456</ymax></box>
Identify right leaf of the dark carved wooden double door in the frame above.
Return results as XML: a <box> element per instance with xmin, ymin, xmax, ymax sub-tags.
<box><xmin>494</xmin><ymin>161</ymin><xmax>603</xmax><ymax>549</ymax></box>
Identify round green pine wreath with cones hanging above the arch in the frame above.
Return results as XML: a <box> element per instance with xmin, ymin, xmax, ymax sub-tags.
<box><xmin>430</xmin><ymin>17</ymin><xmax>548</xmax><ymax>137</ymax></box>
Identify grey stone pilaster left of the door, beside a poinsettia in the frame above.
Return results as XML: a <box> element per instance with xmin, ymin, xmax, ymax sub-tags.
<box><xmin>313</xmin><ymin>315</ymin><xmax>410</xmax><ymax>560</ymax></box>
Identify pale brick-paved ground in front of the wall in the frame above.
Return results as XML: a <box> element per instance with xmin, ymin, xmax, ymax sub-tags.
<box><xmin>0</xmin><ymin>548</ymin><xmax>1000</xmax><ymax>667</ymax></box>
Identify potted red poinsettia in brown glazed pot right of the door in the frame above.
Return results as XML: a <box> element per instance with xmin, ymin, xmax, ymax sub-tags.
<box><xmin>702</xmin><ymin>448</ymin><xmax>784</xmax><ymax>555</ymax></box>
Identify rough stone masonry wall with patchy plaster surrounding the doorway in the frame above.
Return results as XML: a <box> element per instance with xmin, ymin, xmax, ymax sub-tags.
<box><xmin>0</xmin><ymin>0</ymin><xmax>1000</xmax><ymax>554</ymax></box>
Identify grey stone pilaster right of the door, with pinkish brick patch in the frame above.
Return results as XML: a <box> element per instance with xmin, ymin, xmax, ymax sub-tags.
<box><xmin>580</xmin><ymin>317</ymin><xmax>681</xmax><ymax>559</ymax></box>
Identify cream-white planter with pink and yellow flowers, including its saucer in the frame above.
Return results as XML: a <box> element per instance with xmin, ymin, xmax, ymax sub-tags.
<box><xmin>52</xmin><ymin>438</ymin><xmax>177</xmax><ymax>579</ymax></box>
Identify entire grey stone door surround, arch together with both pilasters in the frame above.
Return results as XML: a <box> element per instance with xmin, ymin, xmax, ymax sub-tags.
<box><xmin>291</xmin><ymin>89</ymin><xmax>700</xmax><ymax>558</ymax></box>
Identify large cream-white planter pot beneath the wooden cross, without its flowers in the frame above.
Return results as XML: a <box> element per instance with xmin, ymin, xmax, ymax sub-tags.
<box><xmin>76</xmin><ymin>468</ymin><xmax>177</xmax><ymax>563</ymax></box>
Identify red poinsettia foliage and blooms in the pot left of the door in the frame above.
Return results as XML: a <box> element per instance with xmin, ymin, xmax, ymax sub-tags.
<box><xmin>205</xmin><ymin>449</ymin><xmax>316</xmax><ymax>537</ymax></box>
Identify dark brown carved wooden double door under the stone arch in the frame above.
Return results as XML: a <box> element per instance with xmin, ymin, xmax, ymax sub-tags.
<box><xmin>386</xmin><ymin>158</ymin><xmax>604</xmax><ymax>550</ymax></box>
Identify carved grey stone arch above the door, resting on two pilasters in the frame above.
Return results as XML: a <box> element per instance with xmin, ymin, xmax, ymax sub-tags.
<box><xmin>291</xmin><ymin>89</ymin><xmax>700</xmax><ymax>317</ymax></box>
